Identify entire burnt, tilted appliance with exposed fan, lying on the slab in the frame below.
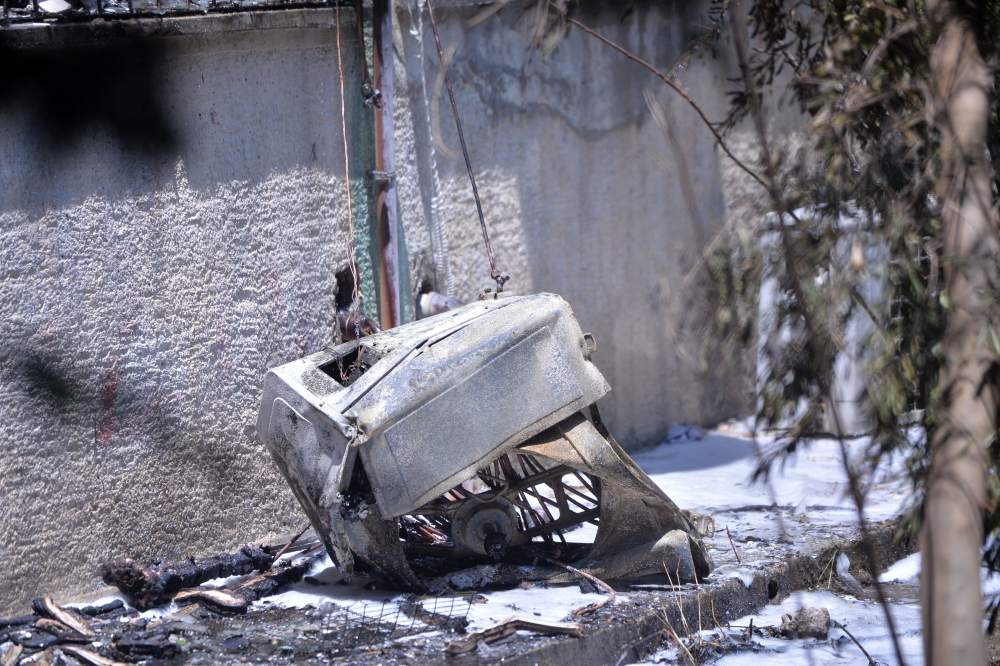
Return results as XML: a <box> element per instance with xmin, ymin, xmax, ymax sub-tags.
<box><xmin>257</xmin><ymin>294</ymin><xmax>713</xmax><ymax>590</ymax></box>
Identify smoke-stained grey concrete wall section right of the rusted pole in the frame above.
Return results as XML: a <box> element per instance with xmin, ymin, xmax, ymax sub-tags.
<box><xmin>397</xmin><ymin>0</ymin><xmax>743</xmax><ymax>447</ymax></box>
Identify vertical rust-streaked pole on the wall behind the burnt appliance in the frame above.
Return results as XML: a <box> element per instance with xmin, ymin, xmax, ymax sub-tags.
<box><xmin>372</xmin><ymin>0</ymin><xmax>400</xmax><ymax>330</ymax></box>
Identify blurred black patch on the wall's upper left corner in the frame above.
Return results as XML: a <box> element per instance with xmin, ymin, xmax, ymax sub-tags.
<box><xmin>0</xmin><ymin>40</ymin><xmax>178</xmax><ymax>159</ymax></box>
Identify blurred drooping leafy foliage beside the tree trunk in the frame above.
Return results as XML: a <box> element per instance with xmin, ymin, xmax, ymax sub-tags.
<box><xmin>692</xmin><ymin>0</ymin><xmax>1000</xmax><ymax>569</ymax></box>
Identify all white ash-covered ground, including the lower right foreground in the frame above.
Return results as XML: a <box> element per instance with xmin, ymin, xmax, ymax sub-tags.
<box><xmin>0</xmin><ymin>424</ymin><xmax>964</xmax><ymax>666</ymax></box>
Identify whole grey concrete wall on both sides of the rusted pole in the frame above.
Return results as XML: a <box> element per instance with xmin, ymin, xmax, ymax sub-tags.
<box><xmin>0</xmin><ymin>0</ymin><xmax>752</xmax><ymax>615</ymax></box>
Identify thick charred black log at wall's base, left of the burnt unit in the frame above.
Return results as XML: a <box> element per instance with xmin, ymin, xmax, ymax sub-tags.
<box><xmin>101</xmin><ymin>546</ymin><xmax>274</xmax><ymax>610</ymax></box>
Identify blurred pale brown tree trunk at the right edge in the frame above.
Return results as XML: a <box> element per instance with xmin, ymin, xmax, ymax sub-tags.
<box><xmin>921</xmin><ymin>2</ymin><xmax>1000</xmax><ymax>666</ymax></box>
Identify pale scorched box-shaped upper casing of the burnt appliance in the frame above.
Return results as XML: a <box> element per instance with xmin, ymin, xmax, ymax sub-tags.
<box><xmin>257</xmin><ymin>294</ymin><xmax>611</xmax><ymax>561</ymax></box>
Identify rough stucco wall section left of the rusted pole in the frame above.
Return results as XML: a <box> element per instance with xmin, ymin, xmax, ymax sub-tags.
<box><xmin>0</xmin><ymin>12</ymin><xmax>390</xmax><ymax>615</ymax></box>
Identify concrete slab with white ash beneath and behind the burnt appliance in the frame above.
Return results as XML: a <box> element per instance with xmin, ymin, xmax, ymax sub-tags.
<box><xmin>0</xmin><ymin>431</ymin><xmax>924</xmax><ymax>666</ymax></box>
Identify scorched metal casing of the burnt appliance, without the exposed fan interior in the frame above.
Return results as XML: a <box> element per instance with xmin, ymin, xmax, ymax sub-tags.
<box><xmin>257</xmin><ymin>294</ymin><xmax>711</xmax><ymax>588</ymax></box>
